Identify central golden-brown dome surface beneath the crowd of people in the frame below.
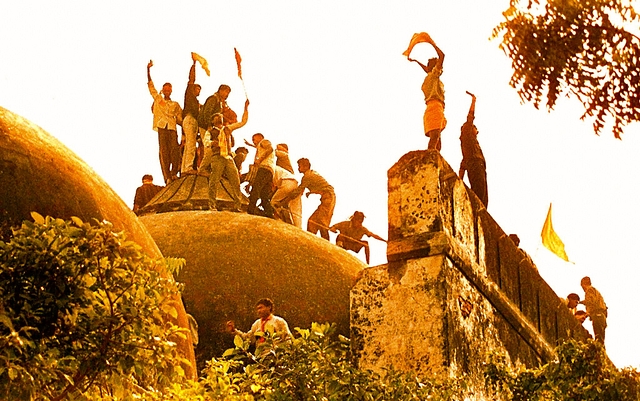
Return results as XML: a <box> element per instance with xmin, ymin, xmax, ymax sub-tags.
<box><xmin>140</xmin><ymin>210</ymin><xmax>366</xmax><ymax>364</ymax></box>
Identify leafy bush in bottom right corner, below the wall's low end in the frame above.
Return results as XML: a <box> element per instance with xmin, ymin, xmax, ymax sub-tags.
<box><xmin>486</xmin><ymin>340</ymin><xmax>640</xmax><ymax>401</ymax></box>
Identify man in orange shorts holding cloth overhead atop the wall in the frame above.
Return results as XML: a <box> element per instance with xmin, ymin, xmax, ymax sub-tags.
<box><xmin>403</xmin><ymin>32</ymin><xmax>447</xmax><ymax>151</ymax></box>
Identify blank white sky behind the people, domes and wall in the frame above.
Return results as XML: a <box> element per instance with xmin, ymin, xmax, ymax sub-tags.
<box><xmin>0</xmin><ymin>0</ymin><xmax>640</xmax><ymax>367</ymax></box>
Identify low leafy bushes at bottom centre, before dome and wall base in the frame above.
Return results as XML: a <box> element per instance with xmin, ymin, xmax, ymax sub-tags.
<box><xmin>185</xmin><ymin>323</ymin><xmax>463</xmax><ymax>401</ymax></box>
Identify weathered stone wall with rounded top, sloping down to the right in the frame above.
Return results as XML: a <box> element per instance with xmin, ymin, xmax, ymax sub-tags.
<box><xmin>351</xmin><ymin>151</ymin><xmax>586</xmax><ymax>382</ymax></box>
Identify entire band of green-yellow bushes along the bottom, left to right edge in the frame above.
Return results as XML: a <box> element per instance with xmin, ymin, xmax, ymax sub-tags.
<box><xmin>0</xmin><ymin>214</ymin><xmax>640</xmax><ymax>401</ymax></box>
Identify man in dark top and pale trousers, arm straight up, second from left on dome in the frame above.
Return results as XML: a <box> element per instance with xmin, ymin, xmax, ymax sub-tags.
<box><xmin>181</xmin><ymin>53</ymin><xmax>201</xmax><ymax>175</ymax></box>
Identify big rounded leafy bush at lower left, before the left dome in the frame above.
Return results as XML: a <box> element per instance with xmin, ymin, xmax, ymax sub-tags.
<box><xmin>0</xmin><ymin>213</ymin><xmax>188</xmax><ymax>400</ymax></box>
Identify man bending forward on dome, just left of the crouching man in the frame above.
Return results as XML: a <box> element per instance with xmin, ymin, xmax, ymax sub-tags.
<box><xmin>286</xmin><ymin>158</ymin><xmax>336</xmax><ymax>241</ymax></box>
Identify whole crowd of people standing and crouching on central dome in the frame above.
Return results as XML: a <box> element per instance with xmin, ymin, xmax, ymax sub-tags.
<box><xmin>134</xmin><ymin>53</ymin><xmax>385</xmax><ymax>263</ymax></box>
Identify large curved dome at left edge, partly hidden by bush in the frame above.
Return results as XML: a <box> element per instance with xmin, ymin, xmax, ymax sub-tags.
<box><xmin>0</xmin><ymin>107</ymin><xmax>193</xmax><ymax>376</ymax></box>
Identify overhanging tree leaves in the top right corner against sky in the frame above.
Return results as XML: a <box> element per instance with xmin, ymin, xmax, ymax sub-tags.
<box><xmin>493</xmin><ymin>0</ymin><xmax>640</xmax><ymax>138</ymax></box>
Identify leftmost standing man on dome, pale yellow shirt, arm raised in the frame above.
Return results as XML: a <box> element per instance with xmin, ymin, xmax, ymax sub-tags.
<box><xmin>147</xmin><ymin>61</ymin><xmax>182</xmax><ymax>183</ymax></box>
